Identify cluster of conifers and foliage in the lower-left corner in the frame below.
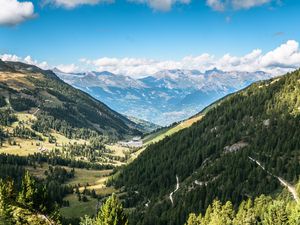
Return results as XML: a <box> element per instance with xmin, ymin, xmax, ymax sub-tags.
<box><xmin>0</xmin><ymin>172</ymin><xmax>59</xmax><ymax>225</ymax></box>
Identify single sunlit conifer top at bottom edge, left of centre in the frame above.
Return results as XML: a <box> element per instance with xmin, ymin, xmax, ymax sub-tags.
<box><xmin>95</xmin><ymin>194</ymin><xmax>128</xmax><ymax>225</ymax></box>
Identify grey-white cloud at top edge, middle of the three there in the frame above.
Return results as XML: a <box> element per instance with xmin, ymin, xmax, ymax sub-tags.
<box><xmin>128</xmin><ymin>0</ymin><xmax>191</xmax><ymax>11</ymax></box>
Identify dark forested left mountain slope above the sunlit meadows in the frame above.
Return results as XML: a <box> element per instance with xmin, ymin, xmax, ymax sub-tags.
<box><xmin>0</xmin><ymin>61</ymin><xmax>140</xmax><ymax>139</ymax></box>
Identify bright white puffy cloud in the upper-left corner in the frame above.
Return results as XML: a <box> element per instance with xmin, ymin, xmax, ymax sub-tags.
<box><xmin>0</xmin><ymin>0</ymin><xmax>34</xmax><ymax>25</ymax></box>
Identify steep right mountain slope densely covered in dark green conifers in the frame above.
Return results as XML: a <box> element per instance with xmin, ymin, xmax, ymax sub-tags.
<box><xmin>113</xmin><ymin>70</ymin><xmax>300</xmax><ymax>225</ymax></box>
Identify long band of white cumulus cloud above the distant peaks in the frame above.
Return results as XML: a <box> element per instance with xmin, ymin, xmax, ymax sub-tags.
<box><xmin>80</xmin><ymin>40</ymin><xmax>300</xmax><ymax>77</ymax></box>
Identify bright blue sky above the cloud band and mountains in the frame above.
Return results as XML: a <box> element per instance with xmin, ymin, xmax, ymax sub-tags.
<box><xmin>0</xmin><ymin>0</ymin><xmax>300</xmax><ymax>76</ymax></box>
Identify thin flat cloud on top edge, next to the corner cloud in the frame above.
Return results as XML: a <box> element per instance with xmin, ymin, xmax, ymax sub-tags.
<box><xmin>44</xmin><ymin>0</ymin><xmax>114</xmax><ymax>9</ymax></box>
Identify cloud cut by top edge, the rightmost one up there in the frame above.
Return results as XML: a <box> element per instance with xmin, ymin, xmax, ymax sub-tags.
<box><xmin>206</xmin><ymin>0</ymin><xmax>274</xmax><ymax>11</ymax></box>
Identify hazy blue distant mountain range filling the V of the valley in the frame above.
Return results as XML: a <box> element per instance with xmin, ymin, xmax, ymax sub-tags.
<box><xmin>54</xmin><ymin>68</ymin><xmax>272</xmax><ymax>126</ymax></box>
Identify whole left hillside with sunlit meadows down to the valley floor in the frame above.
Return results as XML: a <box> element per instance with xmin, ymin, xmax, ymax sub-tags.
<box><xmin>0</xmin><ymin>61</ymin><xmax>144</xmax><ymax>225</ymax></box>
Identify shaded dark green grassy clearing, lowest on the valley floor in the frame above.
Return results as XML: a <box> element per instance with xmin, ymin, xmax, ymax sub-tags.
<box><xmin>60</xmin><ymin>194</ymin><xmax>98</xmax><ymax>218</ymax></box>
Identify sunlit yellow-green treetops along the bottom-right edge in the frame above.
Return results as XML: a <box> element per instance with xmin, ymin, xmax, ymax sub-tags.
<box><xmin>185</xmin><ymin>188</ymin><xmax>300</xmax><ymax>225</ymax></box>
